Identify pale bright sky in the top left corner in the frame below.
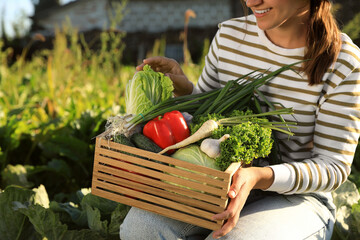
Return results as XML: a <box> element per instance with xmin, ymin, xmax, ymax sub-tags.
<box><xmin>0</xmin><ymin>0</ymin><xmax>74</xmax><ymax>37</ymax></box>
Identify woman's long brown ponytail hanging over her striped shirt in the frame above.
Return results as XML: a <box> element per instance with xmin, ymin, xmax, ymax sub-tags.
<box><xmin>303</xmin><ymin>0</ymin><xmax>341</xmax><ymax>86</ymax></box>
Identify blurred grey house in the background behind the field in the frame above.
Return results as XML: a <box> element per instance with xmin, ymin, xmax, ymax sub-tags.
<box><xmin>32</xmin><ymin>0</ymin><xmax>242</xmax><ymax>61</ymax></box>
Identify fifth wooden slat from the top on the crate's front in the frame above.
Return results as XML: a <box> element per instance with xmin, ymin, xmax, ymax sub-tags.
<box><xmin>94</xmin><ymin>172</ymin><xmax>225</xmax><ymax>213</ymax></box>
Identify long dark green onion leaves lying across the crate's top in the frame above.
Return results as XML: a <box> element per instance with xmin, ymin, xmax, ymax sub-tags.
<box><xmin>125</xmin><ymin>62</ymin><xmax>300</xmax><ymax>130</ymax></box>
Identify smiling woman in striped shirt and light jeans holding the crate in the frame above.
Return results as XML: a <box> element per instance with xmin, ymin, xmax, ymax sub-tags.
<box><xmin>120</xmin><ymin>0</ymin><xmax>360</xmax><ymax>240</ymax></box>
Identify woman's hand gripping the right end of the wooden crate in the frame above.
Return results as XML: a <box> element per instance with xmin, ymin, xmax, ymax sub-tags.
<box><xmin>213</xmin><ymin>167</ymin><xmax>274</xmax><ymax>238</ymax></box>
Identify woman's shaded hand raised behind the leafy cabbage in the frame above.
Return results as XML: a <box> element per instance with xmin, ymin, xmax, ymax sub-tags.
<box><xmin>136</xmin><ymin>57</ymin><xmax>193</xmax><ymax>96</ymax></box>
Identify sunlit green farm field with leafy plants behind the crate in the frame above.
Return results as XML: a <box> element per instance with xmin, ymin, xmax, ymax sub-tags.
<box><xmin>0</xmin><ymin>26</ymin><xmax>360</xmax><ymax>240</ymax></box>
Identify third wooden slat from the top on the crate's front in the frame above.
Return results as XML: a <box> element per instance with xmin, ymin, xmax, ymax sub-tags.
<box><xmin>97</xmin><ymin>156</ymin><xmax>226</xmax><ymax>199</ymax></box>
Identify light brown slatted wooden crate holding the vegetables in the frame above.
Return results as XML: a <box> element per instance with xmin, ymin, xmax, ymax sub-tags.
<box><xmin>92</xmin><ymin>137</ymin><xmax>239</xmax><ymax>230</ymax></box>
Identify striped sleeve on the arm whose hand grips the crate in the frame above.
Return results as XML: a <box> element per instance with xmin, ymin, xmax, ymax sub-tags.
<box><xmin>267</xmin><ymin>66</ymin><xmax>360</xmax><ymax>194</ymax></box>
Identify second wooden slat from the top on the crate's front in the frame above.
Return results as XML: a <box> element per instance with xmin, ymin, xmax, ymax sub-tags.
<box><xmin>97</xmin><ymin>149</ymin><xmax>228</xmax><ymax>189</ymax></box>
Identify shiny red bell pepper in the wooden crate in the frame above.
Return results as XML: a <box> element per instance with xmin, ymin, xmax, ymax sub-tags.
<box><xmin>143</xmin><ymin>110</ymin><xmax>190</xmax><ymax>153</ymax></box>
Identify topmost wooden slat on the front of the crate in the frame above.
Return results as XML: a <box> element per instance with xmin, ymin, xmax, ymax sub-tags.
<box><xmin>97</xmin><ymin>139</ymin><xmax>229</xmax><ymax>179</ymax></box>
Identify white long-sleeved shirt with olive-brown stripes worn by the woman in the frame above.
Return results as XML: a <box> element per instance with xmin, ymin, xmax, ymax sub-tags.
<box><xmin>194</xmin><ymin>15</ymin><xmax>360</xmax><ymax>194</ymax></box>
